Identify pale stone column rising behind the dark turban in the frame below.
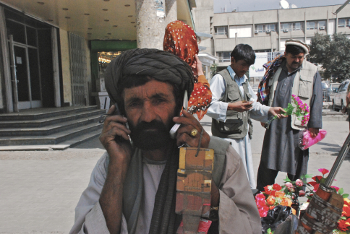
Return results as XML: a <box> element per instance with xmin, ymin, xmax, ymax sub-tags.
<box><xmin>135</xmin><ymin>0</ymin><xmax>177</xmax><ymax>50</ymax></box>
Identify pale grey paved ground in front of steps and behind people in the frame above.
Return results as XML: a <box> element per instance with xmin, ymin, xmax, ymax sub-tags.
<box><xmin>0</xmin><ymin>117</ymin><xmax>350</xmax><ymax>234</ymax></box>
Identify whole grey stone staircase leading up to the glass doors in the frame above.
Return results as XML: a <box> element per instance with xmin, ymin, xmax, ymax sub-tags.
<box><xmin>0</xmin><ymin>106</ymin><xmax>105</xmax><ymax>150</ymax></box>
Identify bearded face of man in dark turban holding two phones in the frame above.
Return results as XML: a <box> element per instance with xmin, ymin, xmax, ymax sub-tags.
<box><xmin>123</xmin><ymin>80</ymin><xmax>176</xmax><ymax>150</ymax></box>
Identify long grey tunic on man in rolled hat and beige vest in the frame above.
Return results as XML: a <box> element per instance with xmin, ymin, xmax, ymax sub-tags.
<box><xmin>260</xmin><ymin>63</ymin><xmax>322</xmax><ymax>175</ymax></box>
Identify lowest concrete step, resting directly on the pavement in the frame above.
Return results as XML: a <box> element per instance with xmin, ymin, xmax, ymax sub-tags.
<box><xmin>0</xmin><ymin>129</ymin><xmax>101</xmax><ymax>151</ymax></box>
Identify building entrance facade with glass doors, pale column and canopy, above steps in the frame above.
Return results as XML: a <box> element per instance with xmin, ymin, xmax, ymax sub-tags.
<box><xmin>0</xmin><ymin>0</ymin><xmax>196</xmax><ymax>113</ymax></box>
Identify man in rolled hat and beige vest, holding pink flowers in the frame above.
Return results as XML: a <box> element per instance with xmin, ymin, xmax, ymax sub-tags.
<box><xmin>257</xmin><ymin>40</ymin><xmax>322</xmax><ymax>191</ymax></box>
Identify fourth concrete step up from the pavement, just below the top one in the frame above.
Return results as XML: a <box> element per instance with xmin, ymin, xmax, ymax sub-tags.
<box><xmin>0</xmin><ymin>109</ymin><xmax>105</xmax><ymax>129</ymax></box>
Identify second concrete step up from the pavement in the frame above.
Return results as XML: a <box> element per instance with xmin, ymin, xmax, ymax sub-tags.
<box><xmin>0</xmin><ymin>123</ymin><xmax>102</xmax><ymax>146</ymax></box>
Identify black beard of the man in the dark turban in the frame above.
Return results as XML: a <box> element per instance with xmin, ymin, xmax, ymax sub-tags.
<box><xmin>130</xmin><ymin>120</ymin><xmax>171</xmax><ymax>150</ymax></box>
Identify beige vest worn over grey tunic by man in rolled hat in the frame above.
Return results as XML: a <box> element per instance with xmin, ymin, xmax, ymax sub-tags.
<box><xmin>268</xmin><ymin>60</ymin><xmax>317</xmax><ymax>130</ymax></box>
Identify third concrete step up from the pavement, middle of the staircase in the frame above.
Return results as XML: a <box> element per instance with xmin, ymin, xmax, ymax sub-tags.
<box><xmin>0</xmin><ymin>116</ymin><xmax>100</xmax><ymax>137</ymax></box>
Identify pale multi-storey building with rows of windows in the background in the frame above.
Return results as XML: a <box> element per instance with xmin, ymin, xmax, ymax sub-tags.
<box><xmin>193</xmin><ymin>0</ymin><xmax>350</xmax><ymax>77</ymax></box>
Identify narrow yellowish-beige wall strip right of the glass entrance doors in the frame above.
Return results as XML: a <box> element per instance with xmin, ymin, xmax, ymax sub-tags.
<box><xmin>60</xmin><ymin>29</ymin><xmax>72</xmax><ymax>106</ymax></box>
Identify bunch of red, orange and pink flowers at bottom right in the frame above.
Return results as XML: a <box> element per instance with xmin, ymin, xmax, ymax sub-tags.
<box><xmin>255</xmin><ymin>168</ymin><xmax>350</xmax><ymax>234</ymax></box>
